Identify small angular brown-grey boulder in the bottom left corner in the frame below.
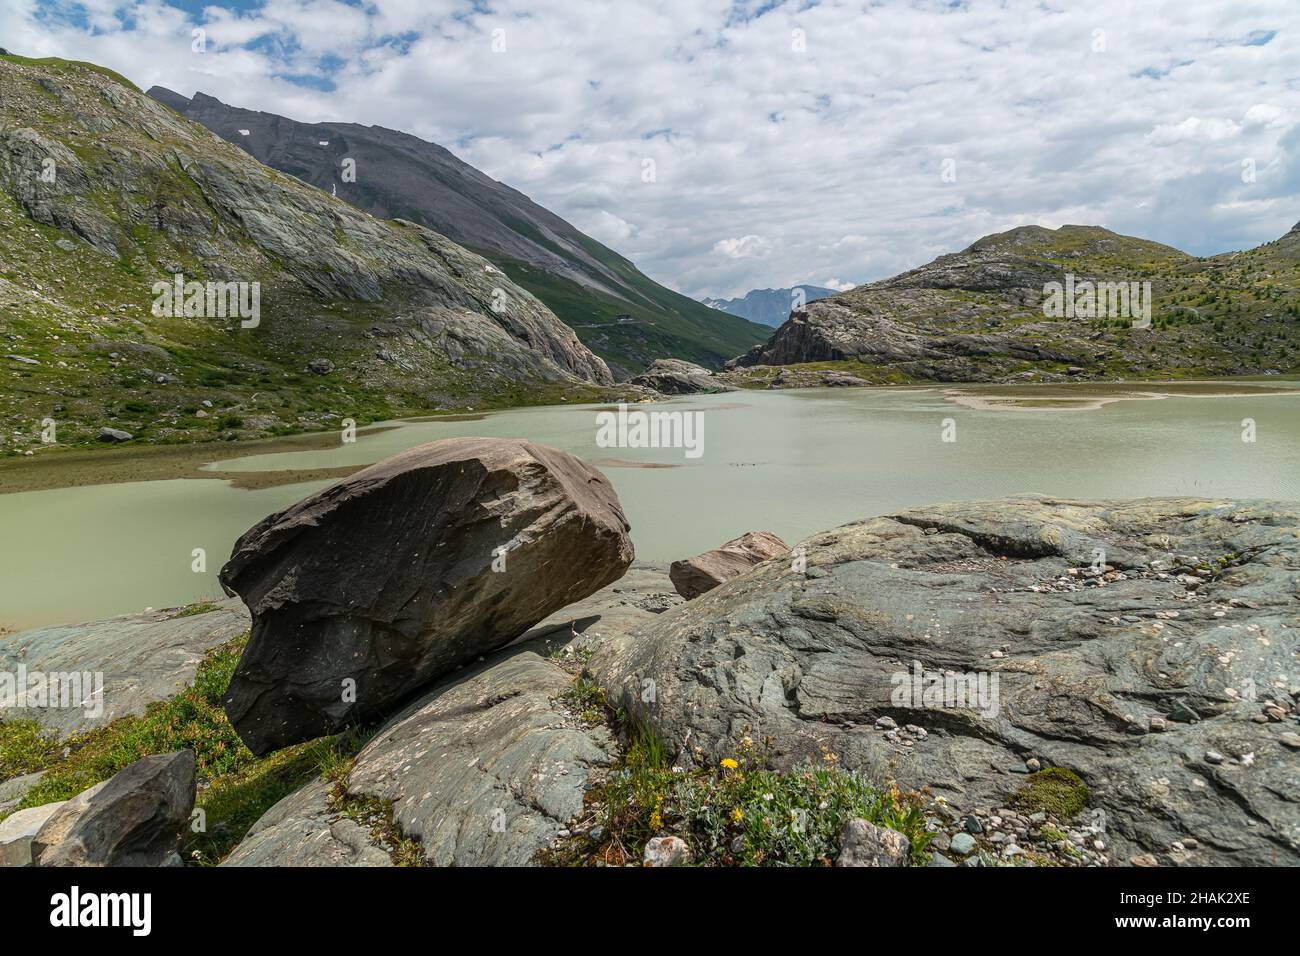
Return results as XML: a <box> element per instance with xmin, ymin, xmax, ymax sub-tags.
<box><xmin>34</xmin><ymin>750</ymin><xmax>195</xmax><ymax>866</ymax></box>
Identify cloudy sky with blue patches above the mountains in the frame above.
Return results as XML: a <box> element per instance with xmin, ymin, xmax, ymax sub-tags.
<box><xmin>0</xmin><ymin>0</ymin><xmax>1300</xmax><ymax>297</ymax></box>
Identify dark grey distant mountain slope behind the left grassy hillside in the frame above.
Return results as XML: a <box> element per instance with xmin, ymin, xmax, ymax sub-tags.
<box><xmin>150</xmin><ymin>87</ymin><xmax>764</xmax><ymax>377</ymax></box>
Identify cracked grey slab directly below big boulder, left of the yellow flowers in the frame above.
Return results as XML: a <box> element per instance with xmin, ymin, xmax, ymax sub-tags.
<box><xmin>348</xmin><ymin>641</ymin><xmax>615</xmax><ymax>866</ymax></box>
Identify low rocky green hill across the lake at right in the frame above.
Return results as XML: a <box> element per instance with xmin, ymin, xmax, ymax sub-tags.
<box><xmin>728</xmin><ymin>226</ymin><xmax>1300</xmax><ymax>385</ymax></box>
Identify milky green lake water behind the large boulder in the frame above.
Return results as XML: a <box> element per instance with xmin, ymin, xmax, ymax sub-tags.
<box><xmin>0</xmin><ymin>382</ymin><xmax>1300</xmax><ymax>628</ymax></box>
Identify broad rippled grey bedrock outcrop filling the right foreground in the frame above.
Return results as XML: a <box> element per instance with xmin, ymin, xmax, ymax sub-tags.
<box><xmin>590</xmin><ymin>497</ymin><xmax>1300</xmax><ymax>865</ymax></box>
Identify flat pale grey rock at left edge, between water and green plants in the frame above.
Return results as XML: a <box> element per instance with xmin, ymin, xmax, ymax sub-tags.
<box><xmin>0</xmin><ymin>600</ymin><xmax>250</xmax><ymax>734</ymax></box>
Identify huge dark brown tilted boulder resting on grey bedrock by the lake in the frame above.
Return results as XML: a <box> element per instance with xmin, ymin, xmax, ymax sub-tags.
<box><xmin>221</xmin><ymin>438</ymin><xmax>633</xmax><ymax>753</ymax></box>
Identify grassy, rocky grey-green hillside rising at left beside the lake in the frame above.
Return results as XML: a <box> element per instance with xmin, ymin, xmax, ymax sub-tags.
<box><xmin>0</xmin><ymin>56</ymin><xmax>612</xmax><ymax>451</ymax></box>
